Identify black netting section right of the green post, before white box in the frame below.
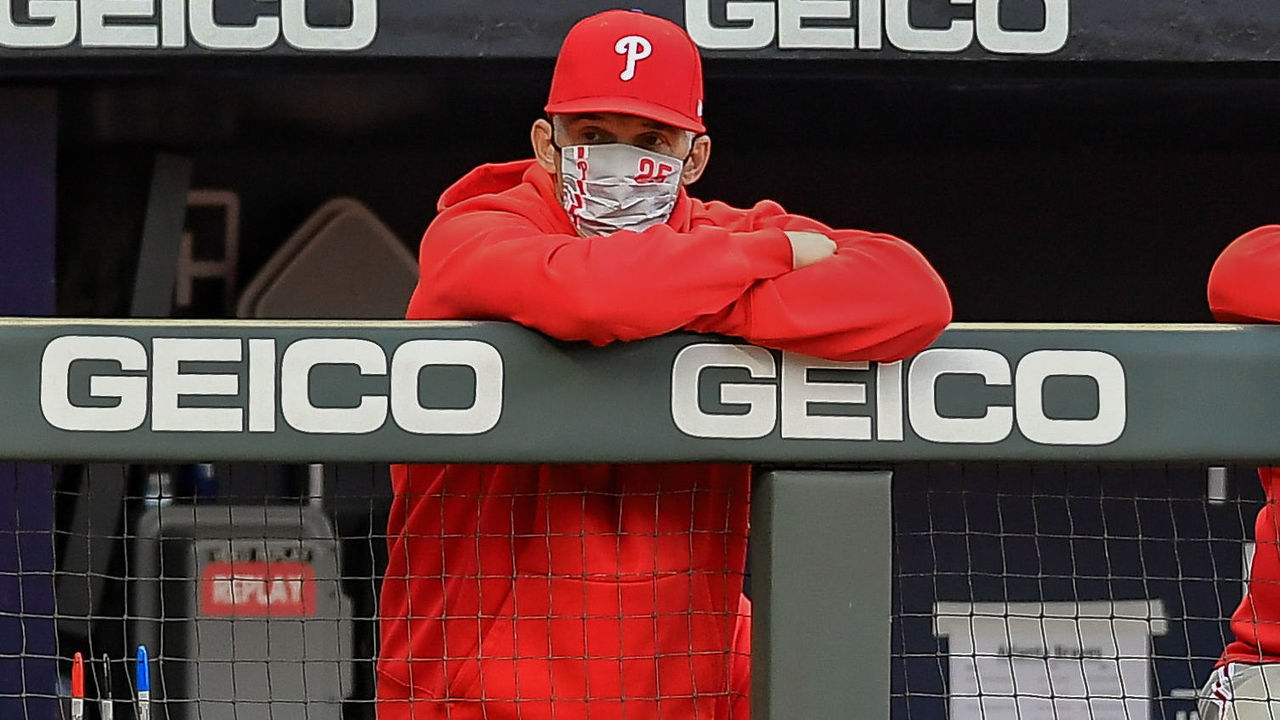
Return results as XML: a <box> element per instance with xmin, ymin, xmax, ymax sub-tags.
<box><xmin>892</xmin><ymin>465</ymin><xmax>1263</xmax><ymax>720</ymax></box>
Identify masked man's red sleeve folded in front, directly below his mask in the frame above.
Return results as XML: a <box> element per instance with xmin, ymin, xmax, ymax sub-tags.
<box><xmin>408</xmin><ymin>209</ymin><xmax>791</xmax><ymax>345</ymax></box>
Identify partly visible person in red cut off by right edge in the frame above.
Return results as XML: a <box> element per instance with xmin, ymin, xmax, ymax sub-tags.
<box><xmin>1199</xmin><ymin>225</ymin><xmax>1280</xmax><ymax>720</ymax></box>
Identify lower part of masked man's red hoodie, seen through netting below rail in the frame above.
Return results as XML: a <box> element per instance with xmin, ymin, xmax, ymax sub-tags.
<box><xmin>379</xmin><ymin>464</ymin><xmax>750</xmax><ymax>720</ymax></box>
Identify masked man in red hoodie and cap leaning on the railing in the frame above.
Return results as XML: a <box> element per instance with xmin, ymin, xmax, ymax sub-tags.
<box><xmin>378</xmin><ymin>10</ymin><xmax>951</xmax><ymax>720</ymax></box>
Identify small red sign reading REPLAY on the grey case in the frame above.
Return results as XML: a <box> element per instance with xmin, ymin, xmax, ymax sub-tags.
<box><xmin>200</xmin><ymin>562</ymin><xmax>316</xmax><ymax>618</ymax></box>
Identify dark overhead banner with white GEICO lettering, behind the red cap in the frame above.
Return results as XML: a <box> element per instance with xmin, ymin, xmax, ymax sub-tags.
<box><xmin>0</xmin><ymin>0</ymin><xmax>1280</xmax><ymax>62</ymax></box>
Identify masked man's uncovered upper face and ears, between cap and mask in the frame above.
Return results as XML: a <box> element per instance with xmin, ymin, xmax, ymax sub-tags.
<box><xmin>532</xmin><ymin>113</ymin><xmax>712</xmax><ymax>197</ymax></box>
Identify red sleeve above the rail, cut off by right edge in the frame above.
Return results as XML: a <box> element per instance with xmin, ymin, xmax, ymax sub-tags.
<box><xmin>1208</xmin><ymin>225</ymin><xmax>1280</xmax><ymax>323</ymax></box>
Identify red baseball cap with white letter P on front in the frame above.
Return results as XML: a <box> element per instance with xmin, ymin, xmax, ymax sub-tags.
<box><xmin>547</xmin><ymin>10</ymin><xmax>707</xmax><ymax>132</ymax></box>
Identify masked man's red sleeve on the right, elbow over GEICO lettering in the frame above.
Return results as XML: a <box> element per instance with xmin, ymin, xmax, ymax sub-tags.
<box><xmin>689</xmin><ymin>206</ymin><xmax>951</xmax><ymax>360</ymax></box>
